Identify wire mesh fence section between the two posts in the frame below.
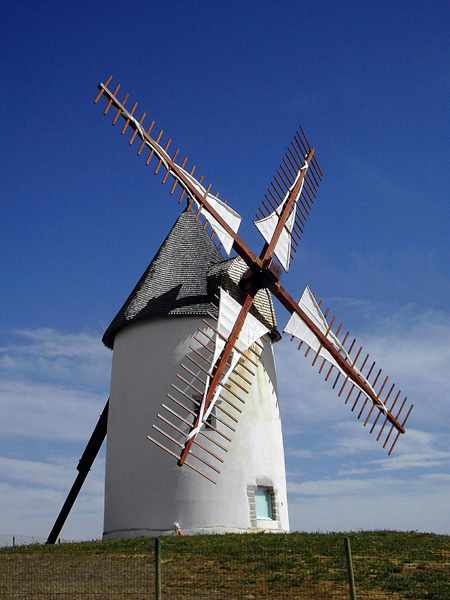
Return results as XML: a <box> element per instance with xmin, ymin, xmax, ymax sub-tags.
<box><xmin>162</xmin><ymin>535</ymin><xmax>348</xmax><ymax>600</ymax></box>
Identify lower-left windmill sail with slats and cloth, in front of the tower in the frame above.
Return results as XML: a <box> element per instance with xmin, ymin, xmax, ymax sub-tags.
<box><xmin>147</xmin><ymin>288</ymin><xmax>269</xmax><ymax>483</ymax></box>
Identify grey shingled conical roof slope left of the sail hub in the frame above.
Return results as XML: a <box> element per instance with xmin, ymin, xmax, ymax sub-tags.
<box><xmin>103</xmin><ymin>210</ymin><xmax>223</xmax><ymax>348</ymax></box>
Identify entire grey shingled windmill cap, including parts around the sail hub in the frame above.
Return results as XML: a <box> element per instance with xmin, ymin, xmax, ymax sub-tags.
<box><xmin>103</xmin><ymin>209</ymin><xmax>279</xmax><ymax>349</ymax></box>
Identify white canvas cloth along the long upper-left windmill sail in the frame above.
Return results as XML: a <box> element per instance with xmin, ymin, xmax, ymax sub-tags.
<box><xmin>112</xmin><ymin>101</ymin><xmax>242</xmax><ymax>254</ymax></box>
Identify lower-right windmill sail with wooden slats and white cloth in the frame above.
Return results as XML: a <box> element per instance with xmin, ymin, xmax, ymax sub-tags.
<box><xmin>284</xmin><ymin>287</ymin><xmax>413</xmax><ymax>454</ymax></box>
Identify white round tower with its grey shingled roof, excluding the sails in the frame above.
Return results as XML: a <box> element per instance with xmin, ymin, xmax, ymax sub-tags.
<box><xmin>104</xmin><ymin>210</ymin><xmax>289</xmax><ymax>537</ymax></box>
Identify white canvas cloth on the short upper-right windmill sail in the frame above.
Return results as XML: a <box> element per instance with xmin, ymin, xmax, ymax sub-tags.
<box><xmin>254</xmin><ymin>161</ymin><xmax>308</xmax><ymax>271</ymax></box>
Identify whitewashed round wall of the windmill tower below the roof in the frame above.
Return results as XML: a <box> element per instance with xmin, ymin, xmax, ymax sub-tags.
<box><xmin>104</xmin><ymin>317</ymin><xmax>289</xmax><ymax>538</ymax></box>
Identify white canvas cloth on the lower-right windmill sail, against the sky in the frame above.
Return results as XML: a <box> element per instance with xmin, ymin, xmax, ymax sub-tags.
<box><xmin>284</xmin><ymin>286</ymin><xmax>387</xmax><ymax>414</ymax></box>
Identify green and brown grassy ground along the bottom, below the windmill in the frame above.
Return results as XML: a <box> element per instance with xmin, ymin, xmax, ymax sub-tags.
<box><xmin>0</xmin><ymin>532</ymin><xmax>450</xmax><ymax>600</ymax></box>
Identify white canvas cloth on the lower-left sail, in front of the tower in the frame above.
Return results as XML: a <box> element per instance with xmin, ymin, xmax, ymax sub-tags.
<box><xmin>187</xmin><ymin>288</ymin><xmax>269</xmax><ymax>439</ymax></box>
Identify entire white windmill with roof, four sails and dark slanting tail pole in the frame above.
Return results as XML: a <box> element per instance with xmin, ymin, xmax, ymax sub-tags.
<box><xmin>48</xmin><ymin>77</ymin><xmax>413</xmax><ymax>543</ymax></box>
